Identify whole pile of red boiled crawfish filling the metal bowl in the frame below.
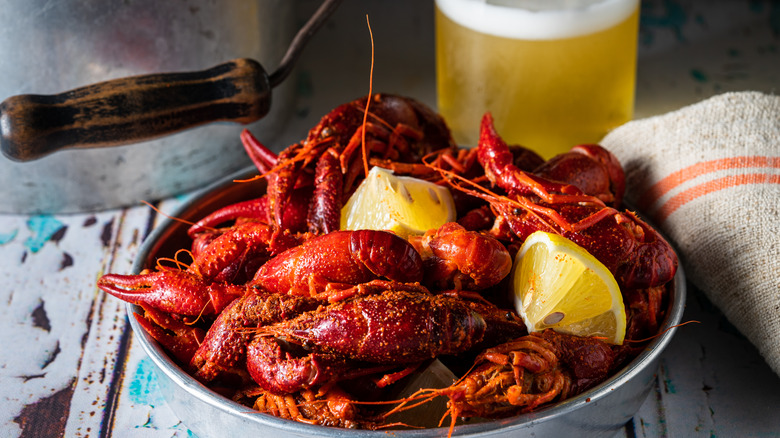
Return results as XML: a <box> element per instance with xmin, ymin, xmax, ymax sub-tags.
<box><xmin>98</xmin><ymin>94</ymin><xmax>677</xmax><ymax>431</ymax></box>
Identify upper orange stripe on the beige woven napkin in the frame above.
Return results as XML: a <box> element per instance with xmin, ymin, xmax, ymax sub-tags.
<box><xmin>637</xmin><ymin>156</ymin><xmax>780</xmax><ymax>211</ymax></box>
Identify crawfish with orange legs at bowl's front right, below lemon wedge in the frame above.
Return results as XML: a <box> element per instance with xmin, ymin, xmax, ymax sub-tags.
<box><xmin>388</xmin><ymin>330</ymin><xmax>615</xmax><ymax>435</ymax></box>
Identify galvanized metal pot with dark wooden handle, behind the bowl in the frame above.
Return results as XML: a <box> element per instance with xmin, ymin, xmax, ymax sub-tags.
<box><xmin>0</xmin><ymin>0</ymin><xmax>341</xmax><ymax>213</ymax></box>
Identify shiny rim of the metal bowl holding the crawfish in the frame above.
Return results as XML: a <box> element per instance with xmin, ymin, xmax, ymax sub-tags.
<box><xmin>126</xmin><ymin>168</ymin><xmax>686</xmax><ymax>438</ymax></box>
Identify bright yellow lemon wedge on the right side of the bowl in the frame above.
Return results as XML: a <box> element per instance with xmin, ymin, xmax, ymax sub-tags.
<box><xmin>511</xmin><ymin>231</ymin><xmax>626</xmax><ymax>345</ymax></box>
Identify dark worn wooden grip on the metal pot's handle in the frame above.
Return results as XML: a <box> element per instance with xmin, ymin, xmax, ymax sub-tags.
<box><xmin>0</xmin><ymin>58</ymin><xmax>271</xmax><ymax>161</ymax></box>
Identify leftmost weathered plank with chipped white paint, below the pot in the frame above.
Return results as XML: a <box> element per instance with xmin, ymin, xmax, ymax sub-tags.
<box><xmin>0</xmin><ymin>213</ymin><xmax>128</xmax><ymax>436</ymax></box>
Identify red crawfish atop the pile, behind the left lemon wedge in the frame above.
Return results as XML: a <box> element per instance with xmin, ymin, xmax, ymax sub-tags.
<box><xmin>260</xmin><ymin>93</ymin><xmax>454</xmax><ymax>234</ymax></box>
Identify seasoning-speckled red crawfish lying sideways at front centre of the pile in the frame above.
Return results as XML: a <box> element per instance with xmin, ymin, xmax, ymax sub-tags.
<box><xmin>247</xmin><ymin>289</ymin><xmax>525</xmax><ymax>393</ymax></box>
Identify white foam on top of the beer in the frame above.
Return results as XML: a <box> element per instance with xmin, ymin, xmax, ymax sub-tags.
<box><xmin>436</xmin><ymin>0</ymin><xmax>639</xmax><ymax>40</ymax></box>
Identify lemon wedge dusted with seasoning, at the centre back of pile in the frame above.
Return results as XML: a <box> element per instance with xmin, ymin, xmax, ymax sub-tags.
<box><xmin>341</xmin><ymin>166</ymin><xmax>455</xmax><ymax>237</ymax></box>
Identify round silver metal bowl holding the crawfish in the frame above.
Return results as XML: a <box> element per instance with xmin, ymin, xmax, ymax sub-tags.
<box><xmin>127</xmin><ymin>169</ymin><xmax>685</xmax><ymax>438</ymax></box>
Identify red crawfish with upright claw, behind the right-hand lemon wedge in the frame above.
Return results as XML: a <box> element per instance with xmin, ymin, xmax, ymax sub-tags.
<box><xmin>470</xmin><ymin>113</ymin><xmax>678</xmax><ymax>288</ymax></box>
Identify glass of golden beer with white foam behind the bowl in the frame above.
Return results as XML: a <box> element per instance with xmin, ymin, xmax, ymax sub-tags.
<box><xmin>436</xmin><ymin>0</ymin><xmax>639</xmax><ymax>159</ymax></box>
